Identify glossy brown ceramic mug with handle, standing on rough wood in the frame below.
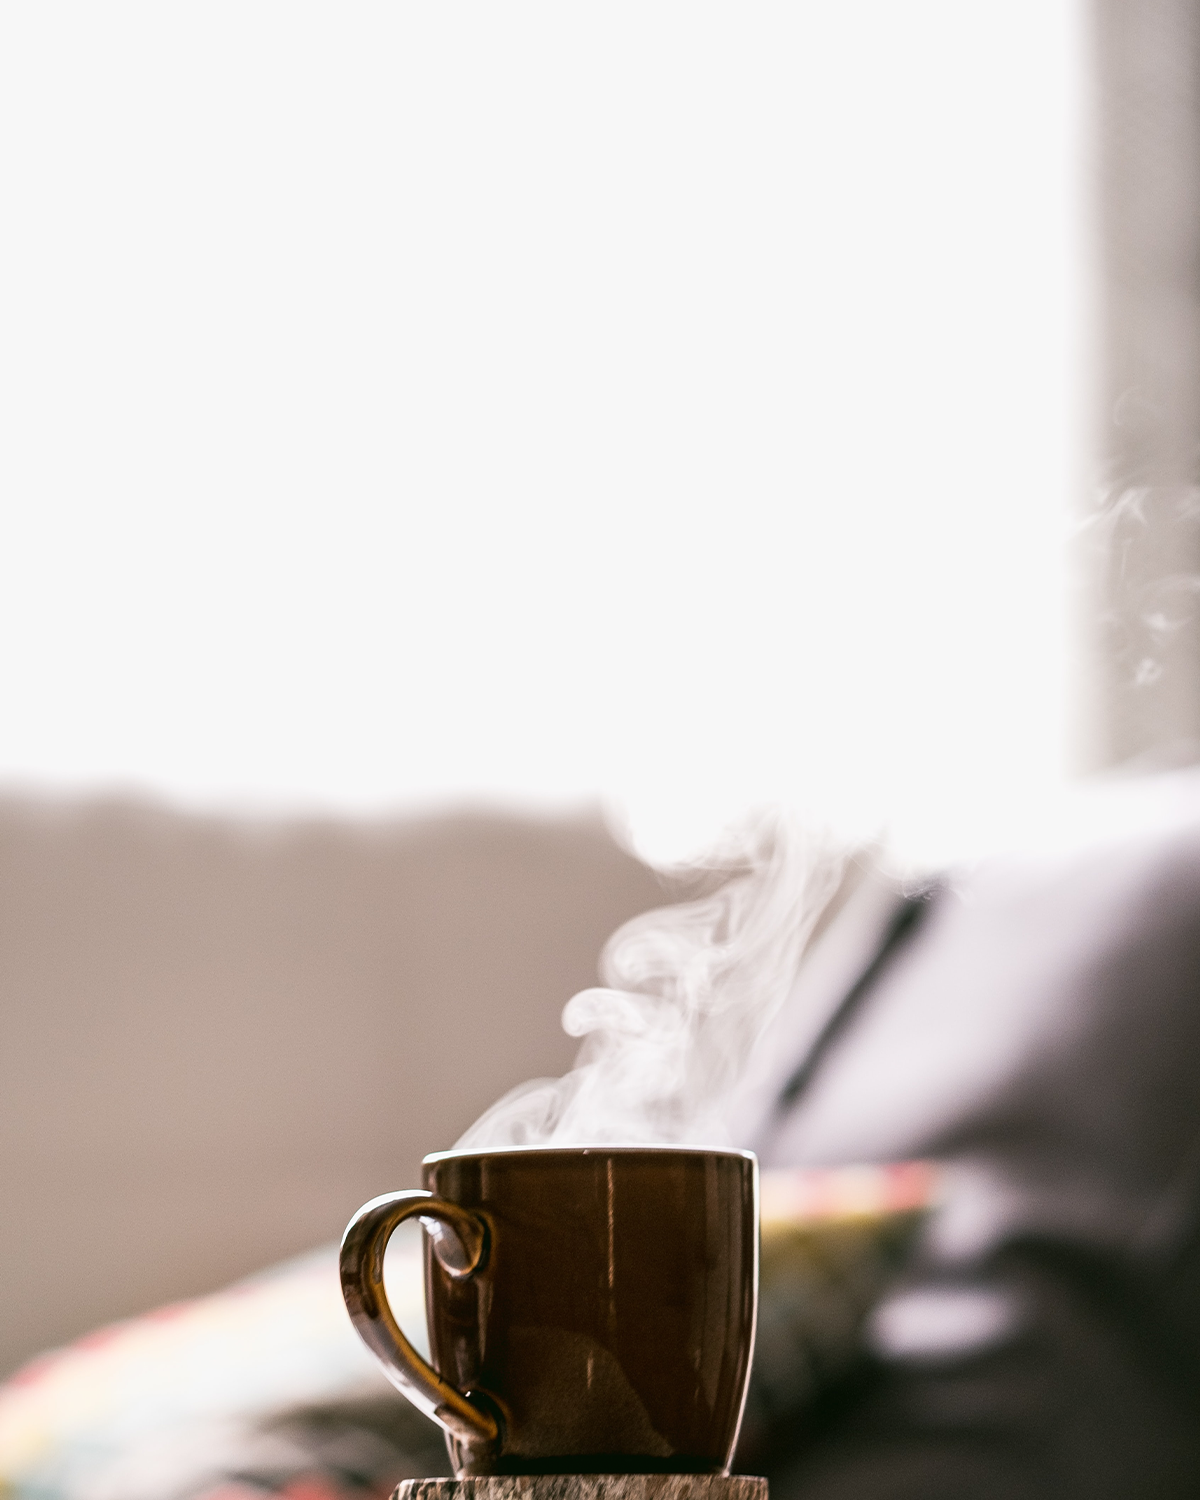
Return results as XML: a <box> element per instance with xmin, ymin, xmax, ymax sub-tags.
<box><xmin>342</xmin><ymin>1146</ymin><xmax>759</xmax><ymax>1475</ymax></box>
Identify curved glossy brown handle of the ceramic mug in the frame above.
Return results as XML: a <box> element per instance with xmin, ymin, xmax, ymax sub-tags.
<box><xmin>342</xmin><ymin>1190</ymin><xmax>500</xmax><ymax>1446</ymax></box>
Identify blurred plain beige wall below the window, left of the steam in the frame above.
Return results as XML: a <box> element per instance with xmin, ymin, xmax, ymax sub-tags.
<box><xmin>0</xmin><ymin>798</ymin><xmax>663</xmax><ymax>1374</ymax></box>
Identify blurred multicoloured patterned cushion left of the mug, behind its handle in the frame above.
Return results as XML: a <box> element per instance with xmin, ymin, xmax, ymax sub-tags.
<box><xmin>0</xmin><ymin>1244</ymin><xmax>447</xmax><ymax>1500</ymax></box>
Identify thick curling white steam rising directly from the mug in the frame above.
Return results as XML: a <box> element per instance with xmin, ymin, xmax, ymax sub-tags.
<box><xmin>458</xmin><ymin>813</ymin><xmax>845</xmax><ymax>1149</ymax></box>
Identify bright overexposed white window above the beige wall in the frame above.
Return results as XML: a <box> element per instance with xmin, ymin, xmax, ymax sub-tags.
<box><xmin>0</xmin><ymin>0</ymin><xmax>1082</xmax><ymax>870</ymax></box>
